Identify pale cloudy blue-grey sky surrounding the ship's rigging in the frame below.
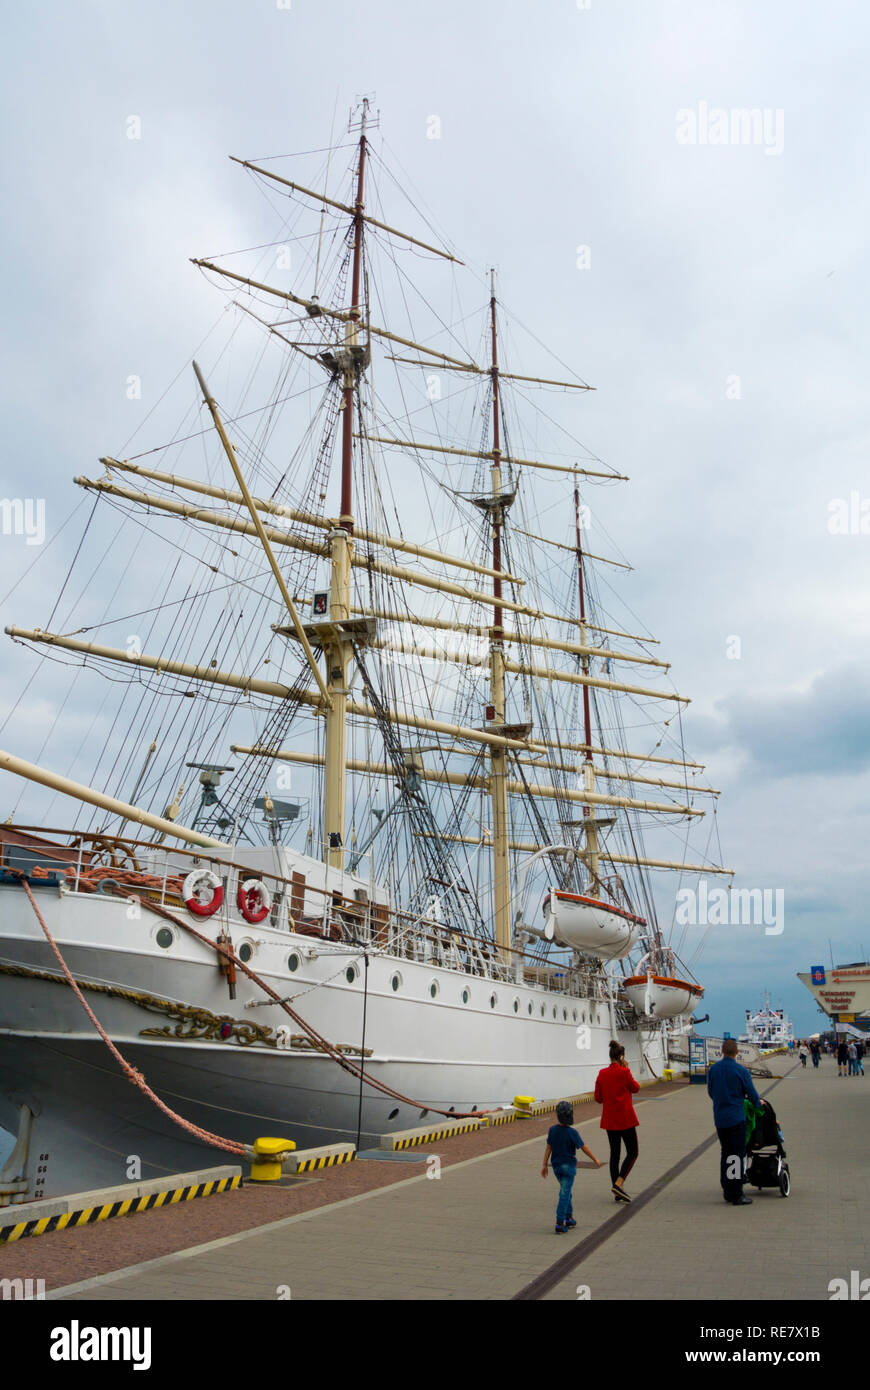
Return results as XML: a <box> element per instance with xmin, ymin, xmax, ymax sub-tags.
<box><xmin>0</xmin><ymin>0</ymin><xmax>870</xmax><ymax>1031</ymax></box>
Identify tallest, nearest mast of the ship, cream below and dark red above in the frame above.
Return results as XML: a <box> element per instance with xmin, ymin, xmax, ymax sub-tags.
<box><xmin>324</xmin><ymin>97</ymin><xmax>368</xmax><ymax>869</ymax></box>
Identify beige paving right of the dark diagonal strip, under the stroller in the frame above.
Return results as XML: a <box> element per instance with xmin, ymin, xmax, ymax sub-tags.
<box><xmin>546</xmin><ymin>1058</ymin><xmax>870</xmax><ymax>1301</ymax></box>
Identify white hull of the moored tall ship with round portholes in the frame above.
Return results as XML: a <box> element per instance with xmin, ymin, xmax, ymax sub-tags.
<box><xmin>0</xmin><ymin>887</ymin><xmax>664</xmax><ymax>1201</ymax></box>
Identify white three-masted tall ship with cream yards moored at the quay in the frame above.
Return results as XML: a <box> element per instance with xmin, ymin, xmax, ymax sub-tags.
<box><xmin>0</xmin><ymin>100</ymin><xmax>727</xmax><ymax>1204</ymax></box>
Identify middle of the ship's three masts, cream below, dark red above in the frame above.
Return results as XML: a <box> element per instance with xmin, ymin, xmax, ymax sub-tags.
<box><xmin>488</xmin><ymin>271</ymin><xmax>513</xmax><ymax>949</ymax></box>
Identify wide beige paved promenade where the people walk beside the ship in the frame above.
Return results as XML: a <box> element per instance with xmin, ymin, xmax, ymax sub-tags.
<box><xmin>48</xmin><ymin>1056</ymin><xmax>870</xmax><ymax>1302</ymax></box>
